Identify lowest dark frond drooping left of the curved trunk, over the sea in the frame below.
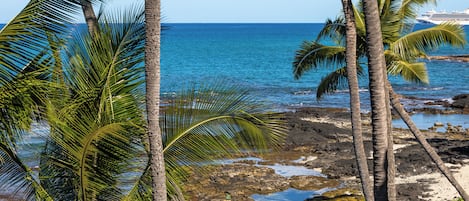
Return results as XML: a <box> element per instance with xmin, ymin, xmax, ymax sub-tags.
<box><xmin>316</xmin><ymin>65</ymin><xmax>363</xmax><ymax>100</ymax></box>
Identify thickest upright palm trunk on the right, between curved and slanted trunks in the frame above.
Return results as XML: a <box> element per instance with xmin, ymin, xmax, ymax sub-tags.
<box><xmin>363</xmin><ymin>0</ymin><xmax>388</xmax><ymax>200</ymax></box>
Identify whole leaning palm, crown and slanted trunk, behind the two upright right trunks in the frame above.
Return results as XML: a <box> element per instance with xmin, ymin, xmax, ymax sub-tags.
<box><xmin>294</xmin><ymin>0</ymin><xmax>465</xmax><ymax>198</ymax></box>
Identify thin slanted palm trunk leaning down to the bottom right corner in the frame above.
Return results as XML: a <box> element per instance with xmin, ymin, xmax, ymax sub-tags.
<box><xmin>386</xmin><ymin>81</ymin><xmax>469</xmax><ymax>200</ymax></box>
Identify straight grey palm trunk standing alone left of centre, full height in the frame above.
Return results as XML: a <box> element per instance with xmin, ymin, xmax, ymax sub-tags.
<box><xmin>145</xmin><ymin>0</ymin><xmax>167</xmax><ymax>201</ymax></box>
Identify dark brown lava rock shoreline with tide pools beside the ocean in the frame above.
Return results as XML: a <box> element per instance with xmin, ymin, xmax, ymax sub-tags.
<box><xmin>180</xmin><ymin>94</ymin><xmax>469</xmax><ymax>200</ymax></box>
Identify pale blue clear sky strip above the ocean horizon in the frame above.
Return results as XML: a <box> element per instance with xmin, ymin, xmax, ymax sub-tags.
<box><xmin>0</xmin><ymin>0</ymin><xmax>462</xmax><ymax>23</ymax></box>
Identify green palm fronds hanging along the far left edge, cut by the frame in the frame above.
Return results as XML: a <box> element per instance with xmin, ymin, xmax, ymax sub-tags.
<box><xmin>0</xmin><ymin>0</ymin><xmax>83</xmax><ymax>199</ymax></box>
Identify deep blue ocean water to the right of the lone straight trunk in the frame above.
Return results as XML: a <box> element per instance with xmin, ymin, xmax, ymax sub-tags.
<box><xmin>161</xmin><ymin>24</ymin><xmax>469</xmax><ymax>111</ymax></box>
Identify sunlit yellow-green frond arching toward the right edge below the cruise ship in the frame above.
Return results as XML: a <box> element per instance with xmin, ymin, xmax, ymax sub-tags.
<box><xmin>389</xmin><ymin>23</ymin><xmax>466</xmax><ymax>59</ymax></box>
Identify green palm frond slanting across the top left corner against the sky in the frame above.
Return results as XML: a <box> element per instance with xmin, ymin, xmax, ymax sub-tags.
<box><xmin>0</xmin><ymin>0</ymin><xmax>79</xmax><ymax>85</ymax></box>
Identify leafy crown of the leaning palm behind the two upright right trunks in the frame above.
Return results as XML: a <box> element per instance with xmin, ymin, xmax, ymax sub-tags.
<box><xmin>293</xmin><ymin>0</ymin><xmax>466</xmax><ymax>100</ymax></box>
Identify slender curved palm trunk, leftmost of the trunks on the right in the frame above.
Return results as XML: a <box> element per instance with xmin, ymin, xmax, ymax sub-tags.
<box><xmin>342</xmin><ymin>0</ymin><xmax>373</xmax><ymax>200</ymax></box>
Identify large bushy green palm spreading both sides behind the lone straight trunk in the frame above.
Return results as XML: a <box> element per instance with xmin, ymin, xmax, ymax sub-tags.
<box><xmin>0</xmin><ymin>2</ymin><xmax>285</xmax><ymax>200</ymax></box>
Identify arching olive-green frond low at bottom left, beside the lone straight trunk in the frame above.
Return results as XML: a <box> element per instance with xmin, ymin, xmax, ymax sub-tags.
<box><xmin>41</xmin><ymin>103</ymin><xmax>143</xmax><ymax>200</ymax></box>
